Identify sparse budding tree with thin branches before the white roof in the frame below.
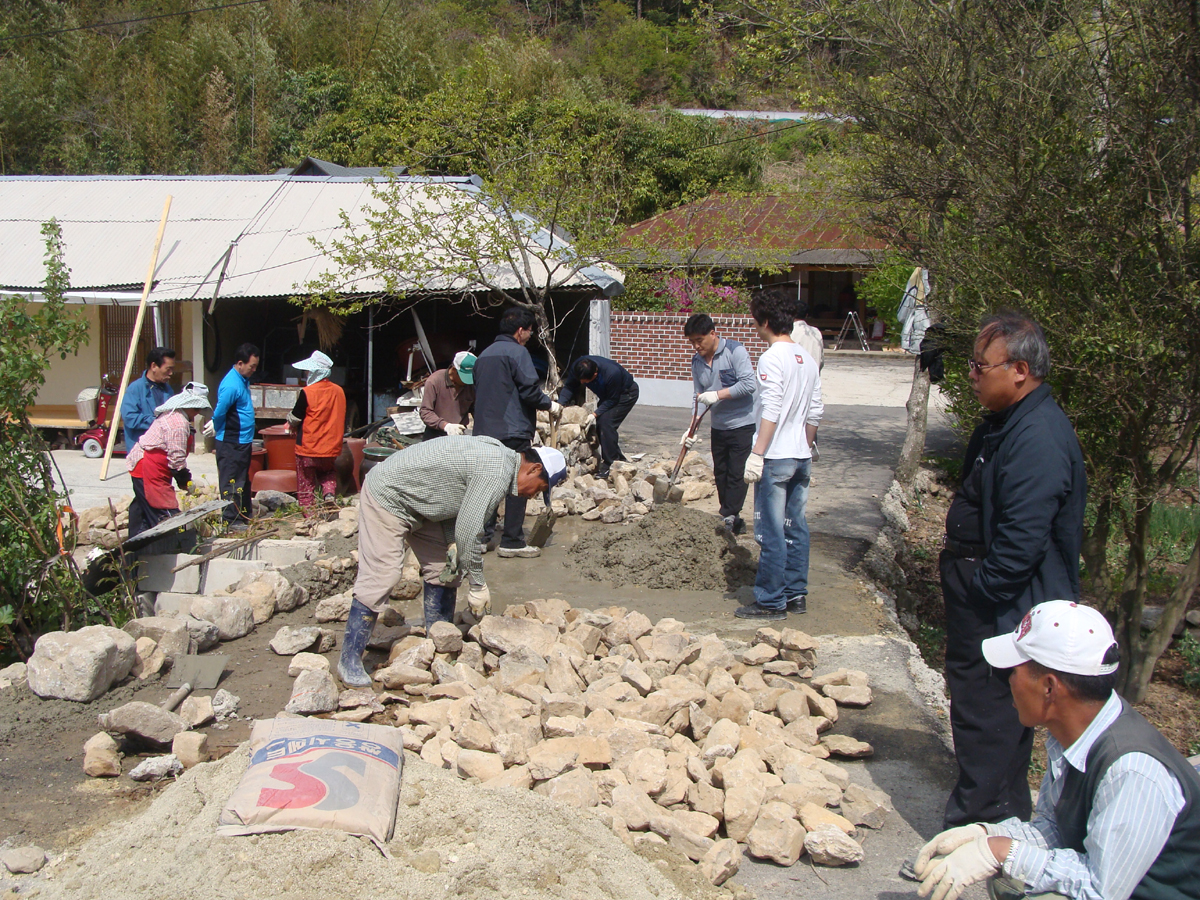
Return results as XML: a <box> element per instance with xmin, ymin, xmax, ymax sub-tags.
<box><xmin>298</xmin><ymin>94</ymin><xmax>620</xmax><ymax>386</ymax></box>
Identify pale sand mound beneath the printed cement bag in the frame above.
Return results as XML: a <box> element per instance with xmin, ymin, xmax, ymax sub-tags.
<box><xmin>37</xmin><ymin>744</ymin><xmax>730</xmax><ymax>900</ymax></box>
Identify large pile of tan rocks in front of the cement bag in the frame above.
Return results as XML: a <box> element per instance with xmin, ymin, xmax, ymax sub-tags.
<box><xmin>282</xmin><ymin>596</ymin><xmax>890</xmax><ymax>884</ymax></box>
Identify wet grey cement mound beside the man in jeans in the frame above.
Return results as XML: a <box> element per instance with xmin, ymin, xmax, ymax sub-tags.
<box><xmin>568</xmin><ymin>503</ymin><xmax>758</xmax><ymax>590</ymax></box>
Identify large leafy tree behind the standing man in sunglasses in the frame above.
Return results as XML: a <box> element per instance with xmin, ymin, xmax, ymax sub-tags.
<box><xmin>763</xmin><ymin>0</ymin><xmax>1200</xmax><ymax>701</ymax></box>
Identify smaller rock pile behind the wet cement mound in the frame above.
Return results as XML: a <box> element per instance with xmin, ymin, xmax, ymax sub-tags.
<box><xmin>538</xmin><ymin>407</ymin><xmax>716</xmax><ymax>524</ymax></box>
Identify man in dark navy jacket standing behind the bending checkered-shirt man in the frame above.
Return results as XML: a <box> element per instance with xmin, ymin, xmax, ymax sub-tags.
<box><xmin>473</xmin><ymin>306</ymin><xmax>562</xmax><ymax>558</ymax></box>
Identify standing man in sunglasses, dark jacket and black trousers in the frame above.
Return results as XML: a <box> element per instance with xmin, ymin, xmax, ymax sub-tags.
<box><xmin>938</xmin><ymin>312</ymin><xmax>1087</xmax><ymax>828</ymax></box>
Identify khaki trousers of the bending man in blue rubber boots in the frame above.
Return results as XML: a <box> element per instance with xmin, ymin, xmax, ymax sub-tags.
<box><xmin>354</xmin><ymin>490</ymin><xmax>461</xmax><ymax>614</ymax></box>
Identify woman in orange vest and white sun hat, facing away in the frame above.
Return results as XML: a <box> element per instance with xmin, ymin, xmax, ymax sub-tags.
<box><xmin>288</xmin><ymin>350</ymin><xmax>346</xmax><ymax>512</ymax></box>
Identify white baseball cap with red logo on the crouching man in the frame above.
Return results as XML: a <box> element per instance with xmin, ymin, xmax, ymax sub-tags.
<box><xmin>983</xmin><ymin>600</ymin><xmax>1117</xmax><ymax>676</ymax></box>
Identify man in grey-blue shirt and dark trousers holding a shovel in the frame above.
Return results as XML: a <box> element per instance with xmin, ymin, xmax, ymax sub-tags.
<box><xmin>679</xmin><ymin>312</ymin><xmax>758</xmax><ymax>534</ymax></box>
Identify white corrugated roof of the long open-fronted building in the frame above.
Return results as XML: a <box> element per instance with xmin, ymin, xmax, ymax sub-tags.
<box><xmin>0</xmin><ymin>175</ymin><xmax>622</xmax><ymax>301</ymax></box>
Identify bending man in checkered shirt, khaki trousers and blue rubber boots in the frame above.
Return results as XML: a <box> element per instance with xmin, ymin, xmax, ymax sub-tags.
<box><xmin>337</xmin><ymin>437</ymin><xmax>566</xmax><ymax>688</ymax></box>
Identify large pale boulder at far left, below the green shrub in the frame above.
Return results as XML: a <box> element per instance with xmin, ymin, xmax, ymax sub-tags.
<box><xmin>25</xmin><ymin>625</ymin><xmax>137</xmax><ymax>703</ymax></box>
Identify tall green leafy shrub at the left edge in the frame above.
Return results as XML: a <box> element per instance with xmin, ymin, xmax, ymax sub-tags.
<box><xmin>0</xmin><ymin>220</ymin><xmax>114</xmax><ymax>659</ymax></box>
